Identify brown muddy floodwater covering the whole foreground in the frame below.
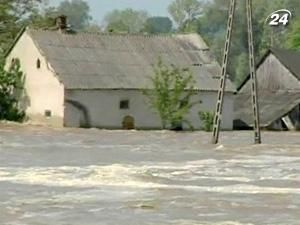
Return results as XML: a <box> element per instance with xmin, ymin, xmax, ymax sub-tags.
<box><xmin>0</xmin><ymin>126</ymin><xmax>300</xmax><ymax>225</ymax></box>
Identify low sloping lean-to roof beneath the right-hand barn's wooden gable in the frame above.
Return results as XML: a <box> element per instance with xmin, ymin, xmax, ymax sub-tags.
<box><xmin>234</xmin><ymin>90</ymin><xmax>300</xmax><ymax>127</ymax></box>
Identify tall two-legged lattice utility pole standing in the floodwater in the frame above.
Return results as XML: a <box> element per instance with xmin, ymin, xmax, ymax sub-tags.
<box><xmin>212</xmin><ymin>0</ymin><xmax>261</xmax><ymax>144</ymax></box>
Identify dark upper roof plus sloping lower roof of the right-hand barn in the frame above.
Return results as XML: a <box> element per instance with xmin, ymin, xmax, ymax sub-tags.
<box><xmin>234</xmin><ymin>48</ymin><xmax>300</xmax><ymax>127</ymax></box>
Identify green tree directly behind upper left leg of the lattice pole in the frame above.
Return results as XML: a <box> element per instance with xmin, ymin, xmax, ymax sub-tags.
<box><xmin>198</xmin><ymin>0</ymin><xmax>248</xmax><ymax>81</ymax></box>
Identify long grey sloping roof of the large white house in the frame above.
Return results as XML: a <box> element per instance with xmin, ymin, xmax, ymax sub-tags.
<box><xmin>26</xmin><ymin>29</ymin><xmax>235</xmax><ymax>92</ymax></box>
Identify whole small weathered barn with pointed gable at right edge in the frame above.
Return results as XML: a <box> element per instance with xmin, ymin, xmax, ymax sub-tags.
<box><xmin>234</xmin><ymin>48</ymin><xmax>300</xmax><ymax>130</ymax></box>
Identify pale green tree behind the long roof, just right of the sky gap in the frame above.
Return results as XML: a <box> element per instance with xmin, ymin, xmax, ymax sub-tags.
<box><xmin>168</xmin><ymin>0</ymin><xmax>202</xmax><ymax>31</ymax></box>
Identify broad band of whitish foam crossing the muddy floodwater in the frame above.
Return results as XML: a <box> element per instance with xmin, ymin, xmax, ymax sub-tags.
<box><xmin>0</xmin><ymin>160</ymin><xmax>300</xmax><ymax>194</ymax></box>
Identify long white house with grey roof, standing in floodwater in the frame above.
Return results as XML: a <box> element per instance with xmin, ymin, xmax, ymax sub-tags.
<box><xmin>7</xmin><ymin>23</ymin><xmax>235</xmax><ymax>130</ymax></box>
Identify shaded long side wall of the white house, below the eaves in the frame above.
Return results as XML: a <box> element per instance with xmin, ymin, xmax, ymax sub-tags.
<box><xmin>64</xmin><ymin>90</ymin><xmax>234</xmax><ymax>130</ymax></box>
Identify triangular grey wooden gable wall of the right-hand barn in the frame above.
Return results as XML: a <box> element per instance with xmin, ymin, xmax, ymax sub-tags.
<box><xmin>240</xmin><ymin>54</ymin><xmax>300</xmax><ymax>93</ymax></box>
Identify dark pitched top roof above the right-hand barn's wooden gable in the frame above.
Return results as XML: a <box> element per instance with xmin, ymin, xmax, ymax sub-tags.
<box><xmin>237</xmin><ymin>48</ymin><xmax>300</xmax><ymax>91</ymax></box>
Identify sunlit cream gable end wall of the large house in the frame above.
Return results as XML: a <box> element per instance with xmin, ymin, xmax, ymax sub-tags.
<box><xmin>7</xmin><ymin>32</ymin><xmax>64</xmax><ymax>126</ymax></box>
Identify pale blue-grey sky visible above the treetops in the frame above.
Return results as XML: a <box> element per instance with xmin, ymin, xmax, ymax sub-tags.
<box><xmin>50</xmin><ymin>0</ymin><xmax>173</xmax><ymax>23</ymax></box>
